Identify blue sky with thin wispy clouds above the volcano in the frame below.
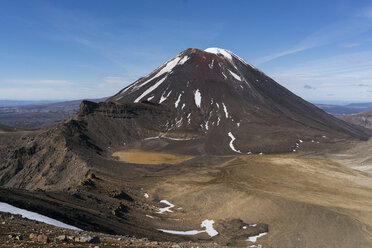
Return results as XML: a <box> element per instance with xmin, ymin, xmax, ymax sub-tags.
<box><xmin>0</xmin><ymin>0</ymin><xmax>372</xmax><ymax>103</ymax></box>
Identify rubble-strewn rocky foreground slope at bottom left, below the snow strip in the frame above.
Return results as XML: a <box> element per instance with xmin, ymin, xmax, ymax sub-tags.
<box><xmin>0</xmin><ymin>212</ymin><xmax>221</xmax><ymax>248</ymax></box>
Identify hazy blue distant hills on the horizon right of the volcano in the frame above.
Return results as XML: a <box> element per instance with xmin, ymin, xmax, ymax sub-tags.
<box><xmin>315</xmin><ymin>102</ymin><xmax>372</xmax><ymax>116</ymax></box>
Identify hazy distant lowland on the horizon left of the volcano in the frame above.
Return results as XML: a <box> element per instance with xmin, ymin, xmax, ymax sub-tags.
<box><xmin>0</xmin><ymin>98</ymin><xmax>106</xmax><ymax>129</ymax></box>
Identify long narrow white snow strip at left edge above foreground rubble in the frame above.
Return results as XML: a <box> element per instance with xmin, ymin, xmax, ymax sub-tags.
<box><xmin>0</xmin><ymin>202</ymin><xmax>81</xmax><ymax>230</ymax></box>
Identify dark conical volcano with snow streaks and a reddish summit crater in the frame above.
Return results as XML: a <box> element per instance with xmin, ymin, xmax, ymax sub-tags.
<box><xmin>107</xmin><ymin>48</ymin><xmax>368</xmax><ymax>154</ymax></box>
